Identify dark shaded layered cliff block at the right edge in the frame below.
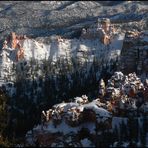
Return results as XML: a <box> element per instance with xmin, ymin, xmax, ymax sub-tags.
<box><xmin>119</xmin><ymin>31</ymin><xmax>148</xmax><ymax>75</ymax></box>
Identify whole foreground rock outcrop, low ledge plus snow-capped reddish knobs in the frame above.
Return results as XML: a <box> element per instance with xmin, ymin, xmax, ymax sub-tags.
<box><xmin>26</xmin><ymin>72</ymin><xmax>148</xmax><ymax>147</ymax></box>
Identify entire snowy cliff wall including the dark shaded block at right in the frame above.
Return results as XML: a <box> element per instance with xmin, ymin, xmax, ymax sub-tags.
<box><xmin>0</xmin><ymin>25</ymin><xmax>148</xmax><ymax>100</ymax></box>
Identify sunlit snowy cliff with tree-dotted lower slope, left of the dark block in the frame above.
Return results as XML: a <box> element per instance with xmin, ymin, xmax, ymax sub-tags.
<box><xmin>0</xmin><ymin>29</ymin><xmax>124</xmax><ymax>96</ymax></box>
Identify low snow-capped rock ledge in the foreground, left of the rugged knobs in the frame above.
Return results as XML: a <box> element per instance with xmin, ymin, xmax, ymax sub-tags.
<box><xmin>26</xmin><ymin>96</ymin><xmax>112</xmax><ymax>146</ymax></box>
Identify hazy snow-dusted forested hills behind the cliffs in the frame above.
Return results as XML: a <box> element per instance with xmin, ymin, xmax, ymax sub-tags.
<box><xmin>0</xmin><ymin>1</ymin><xmax>148</xmax><ymax>40</ymax></box>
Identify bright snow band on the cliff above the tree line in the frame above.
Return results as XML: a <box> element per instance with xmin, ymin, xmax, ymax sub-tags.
<box><xmin>0</xmin><ymin>30</ymin><xmax>124</xmax><ymax>78</ymax></box>
